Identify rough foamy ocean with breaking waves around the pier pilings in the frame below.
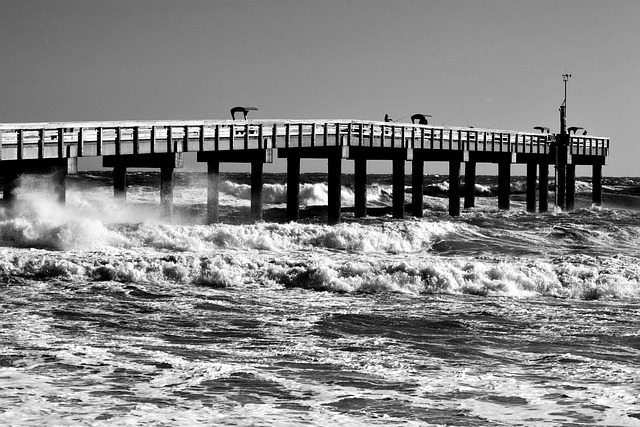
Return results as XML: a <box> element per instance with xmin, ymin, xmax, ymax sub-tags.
<box><xmin>0</xmin><ymin>172</ymin><xmax>640</xmax><ymax>426</ymax></box>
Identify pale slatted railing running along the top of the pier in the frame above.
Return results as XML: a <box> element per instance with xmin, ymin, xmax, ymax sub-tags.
<box><xmin>0</xmin><ymin>120</ymin><xmax>609</xmax><ymax>160</ymax></box>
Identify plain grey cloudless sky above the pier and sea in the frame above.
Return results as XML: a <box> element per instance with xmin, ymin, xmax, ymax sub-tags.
<box><xmin>0</xmin><ymin>0</ymin><xmax>640</xmax><ymax>176</ymax></box>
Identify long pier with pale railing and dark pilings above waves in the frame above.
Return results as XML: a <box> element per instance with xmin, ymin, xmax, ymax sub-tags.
<box><xmin>0</xmin><ymin>120</ymin><xmax>609</xmax><ymax>224</ymax></box>
